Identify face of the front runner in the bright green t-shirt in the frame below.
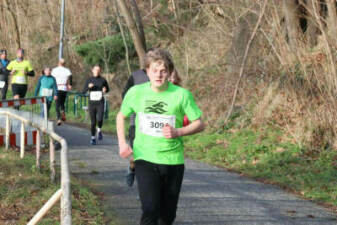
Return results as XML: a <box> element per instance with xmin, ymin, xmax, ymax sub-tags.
<box><xmin>146</xmin><ymin>61</ymin><xmax>170</xmax><ymax>89</ymax></box>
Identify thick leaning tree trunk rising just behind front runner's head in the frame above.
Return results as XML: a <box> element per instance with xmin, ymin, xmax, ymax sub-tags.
<box><xmin>117</xmin><ymin>0</ymin><xmax>145</xmax><ymax>68</ymax></box>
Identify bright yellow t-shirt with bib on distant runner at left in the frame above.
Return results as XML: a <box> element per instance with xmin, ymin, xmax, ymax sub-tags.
<box><xmin>7</xmin><ymin>59</ymin><xmax>33</xmax><ymax>84</ymax></box>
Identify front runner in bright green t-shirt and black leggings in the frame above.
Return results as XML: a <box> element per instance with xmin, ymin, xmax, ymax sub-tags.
<box><xmin>116</xmin><ymin>49</ymin><xmax>204</xmax><ymax>225</ymax></box>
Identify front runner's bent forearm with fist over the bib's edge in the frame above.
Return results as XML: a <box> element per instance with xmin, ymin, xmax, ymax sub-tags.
<box><xmin>163</xmin><ymin>118</ymin><xmax>206</xmax><ymax>138</ymax></box>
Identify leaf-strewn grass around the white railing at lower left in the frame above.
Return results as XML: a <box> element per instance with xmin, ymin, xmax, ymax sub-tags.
<box><xmin>0</xmin><ymin>149</ymin><xmax>105</xmax><ymax>225</ymax></box>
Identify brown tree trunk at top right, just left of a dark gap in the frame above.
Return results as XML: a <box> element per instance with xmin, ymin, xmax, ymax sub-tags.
<box><xmin>283</xmin><ymin>0</ymin><xmax>299</xmax><ymax>48</ymax></box>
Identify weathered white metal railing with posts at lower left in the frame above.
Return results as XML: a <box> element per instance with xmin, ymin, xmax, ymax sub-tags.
<box><xmin>0</xmin><ymin>107</ymin><xmax>72</xmax><ymax>225</ymax></box>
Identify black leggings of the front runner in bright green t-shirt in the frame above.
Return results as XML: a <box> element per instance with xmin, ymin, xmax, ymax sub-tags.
<box><xmin>135</xmin><ymin>160</ymin><xmax>185</xmax><ymax>225</ymax></box>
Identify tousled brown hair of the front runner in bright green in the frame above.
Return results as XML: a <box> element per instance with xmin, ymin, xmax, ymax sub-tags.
<box><xmin>145</xmin><ymin>48</ymin><xmax>174</xmax><ymax>73</ymax></box>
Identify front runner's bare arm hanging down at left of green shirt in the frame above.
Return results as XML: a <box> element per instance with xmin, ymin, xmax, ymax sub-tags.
<box><xmin>116</xmin><ymin>112</ymin><xmax>132</xmax><ymax>158</ymax></box>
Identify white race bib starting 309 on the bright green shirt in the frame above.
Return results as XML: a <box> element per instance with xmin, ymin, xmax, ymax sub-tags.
<box><xmin>137</xmin><ymin>113</ymin><xmax>176</xmax><ymax>137</ymax></box>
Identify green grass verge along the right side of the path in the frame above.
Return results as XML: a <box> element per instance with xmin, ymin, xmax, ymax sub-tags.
<box><xmin>184</xmin><ymin>125</ymin><xmax>337</xmax><ymax>210</ymax></box>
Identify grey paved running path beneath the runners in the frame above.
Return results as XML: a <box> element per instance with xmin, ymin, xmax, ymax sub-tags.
<box><xmin>56</xmin><ymin>125</ymin><xmax>337</xmax><ymax>225</ymax></box>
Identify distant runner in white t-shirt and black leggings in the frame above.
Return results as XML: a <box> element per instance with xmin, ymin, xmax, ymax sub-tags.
<box><xmin>51</xmin><ymin>59</ymin><xmax>72</xmax><ymax>126</ymax></box>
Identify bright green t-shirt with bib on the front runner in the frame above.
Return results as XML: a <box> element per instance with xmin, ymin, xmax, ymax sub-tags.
<box><xmin>121</xmin><ymin>82</ymin><xmax>202</xmax><ymax>165</ymax></box>
